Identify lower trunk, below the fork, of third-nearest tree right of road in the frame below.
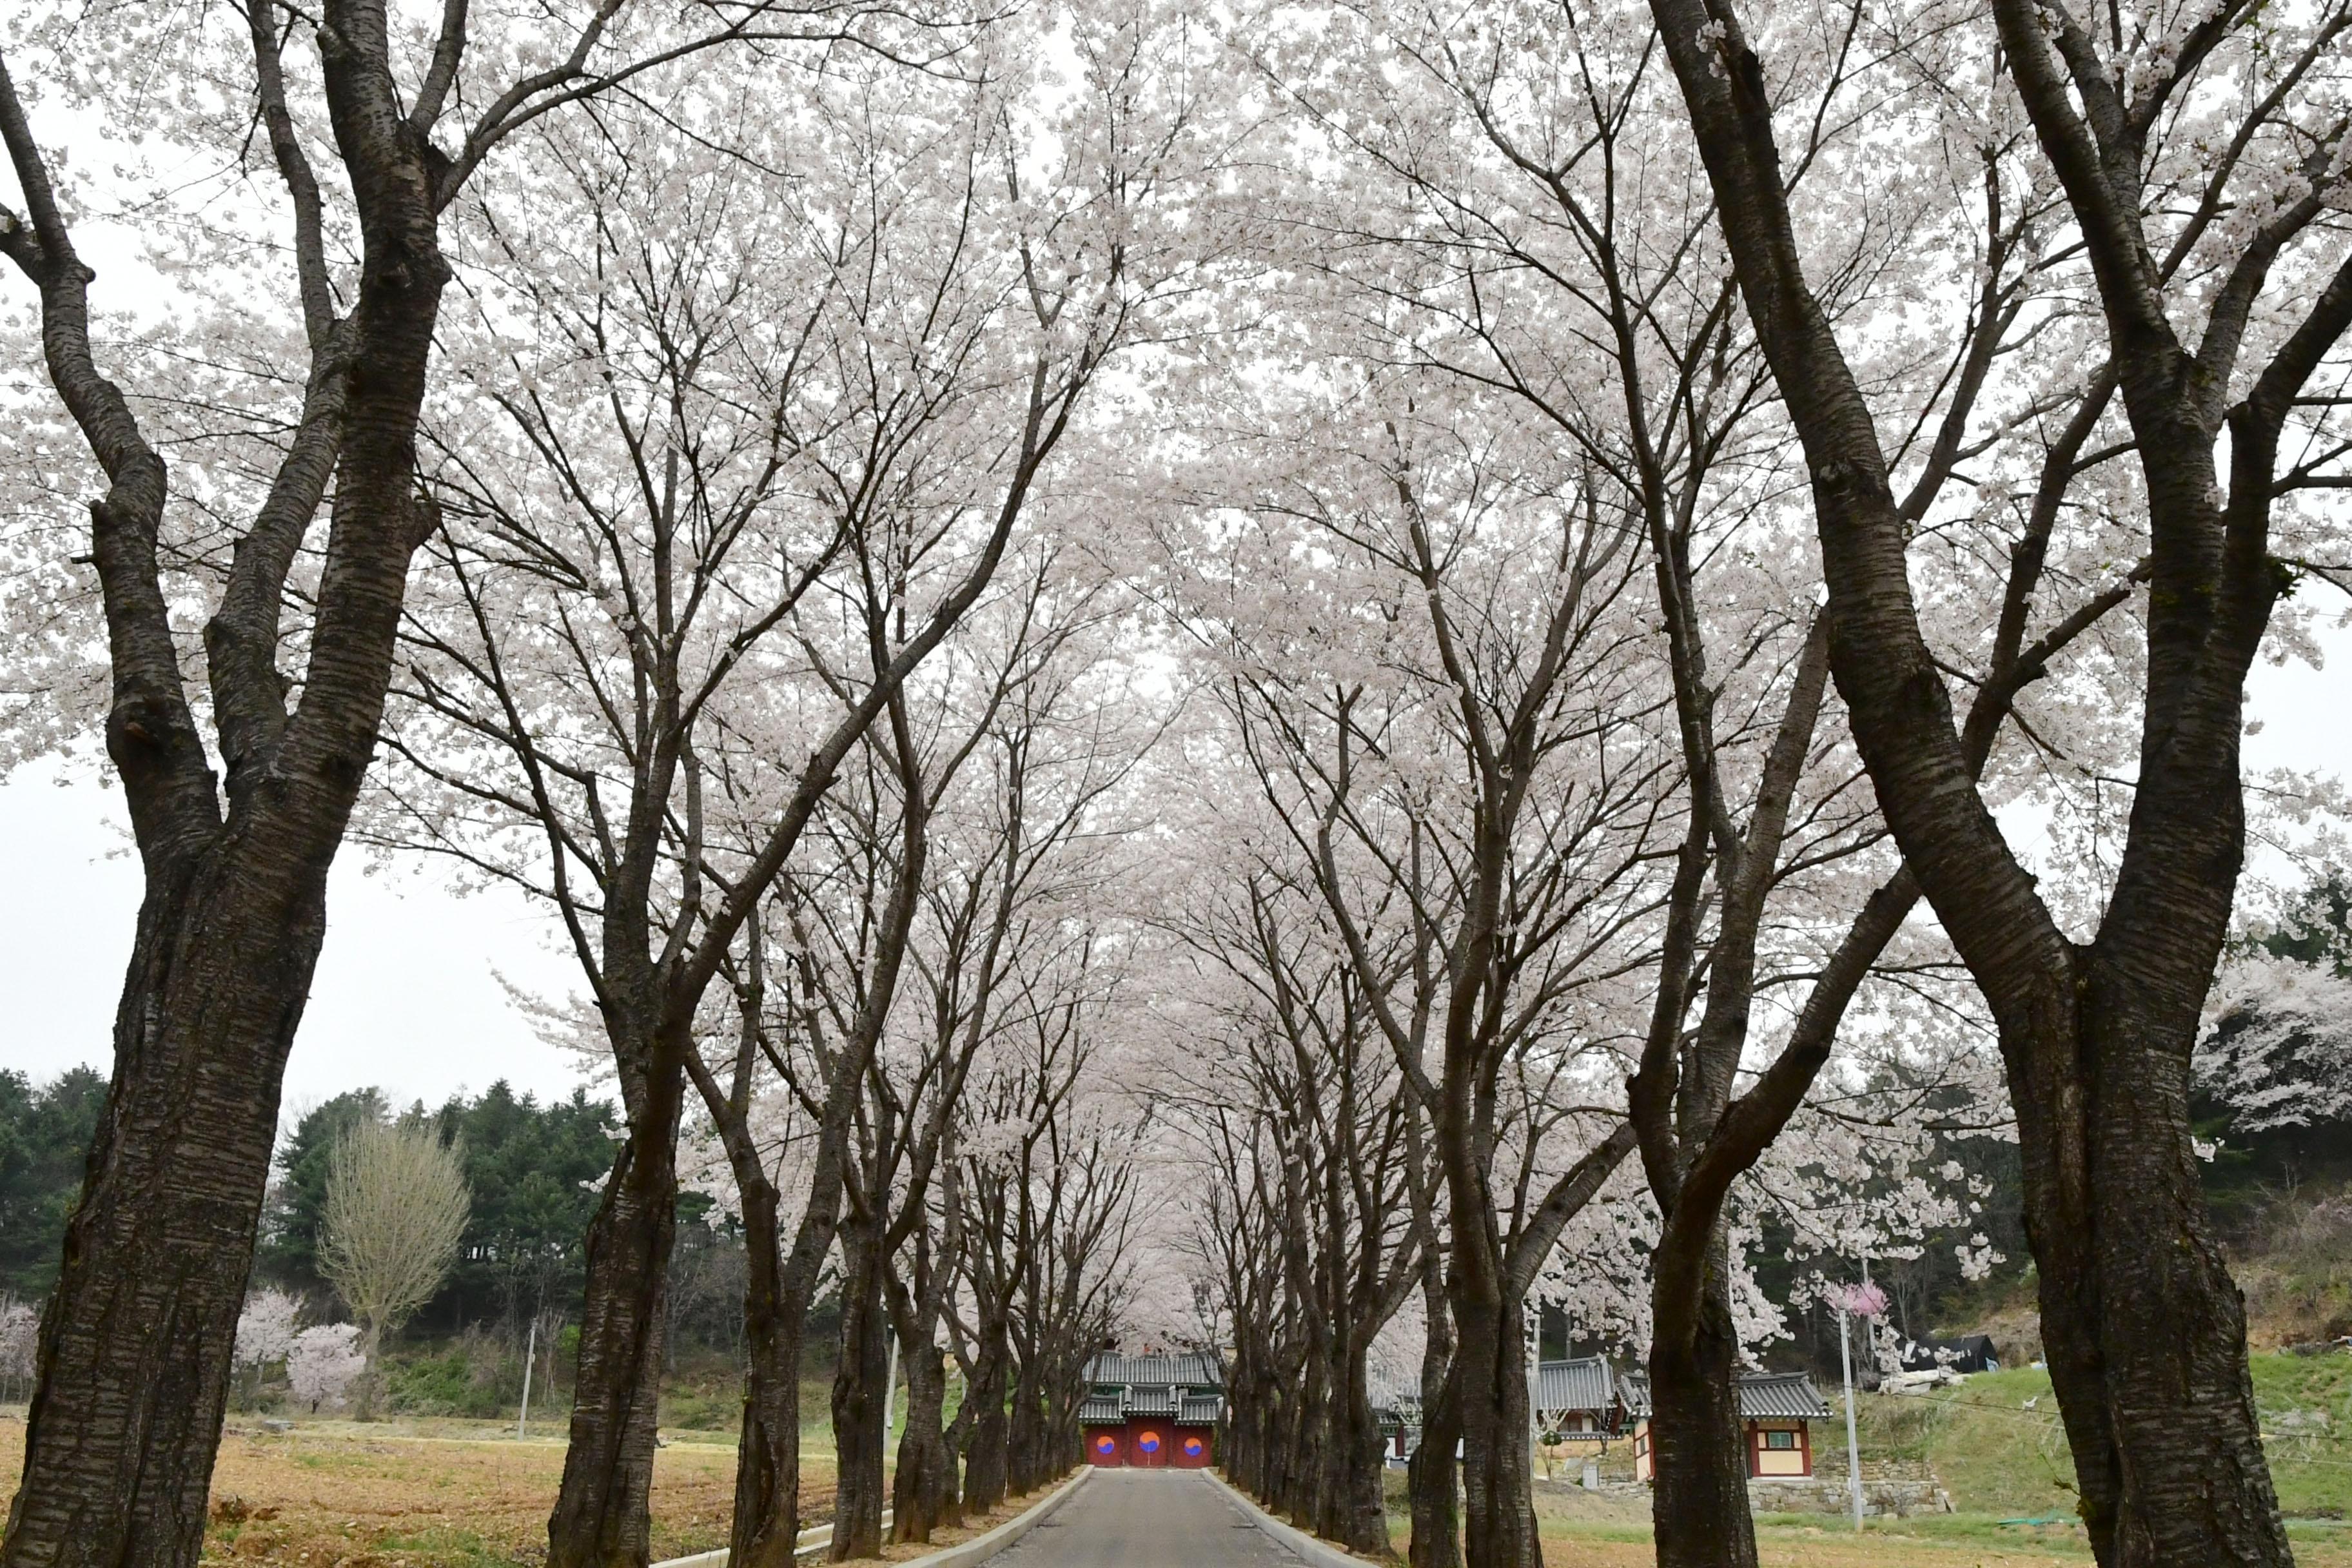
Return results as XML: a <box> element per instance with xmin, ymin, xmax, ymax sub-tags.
<box><xmin>1453</xmin><ymin>1298</ymin><xmax>1543</xmax><ymax>1568</ymax></box>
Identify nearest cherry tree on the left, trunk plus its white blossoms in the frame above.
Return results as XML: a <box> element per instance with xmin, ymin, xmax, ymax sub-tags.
<box><xmin>0</xmin><ymin>0</ymin><xmax>870</xmax><ymax>1565</ymax></box>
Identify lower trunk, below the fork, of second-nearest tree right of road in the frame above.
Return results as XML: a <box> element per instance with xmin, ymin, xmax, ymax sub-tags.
<box><xmin>1649</xmin><ymin>1260</ymin><xmax>1757</xmax><ymax>1568</ymax></box>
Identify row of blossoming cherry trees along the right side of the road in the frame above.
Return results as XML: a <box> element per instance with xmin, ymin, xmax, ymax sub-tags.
<box><xmin>1133</xmin><ymin>0</ymin><xmax>2352</xmax><ymax>1563</ymax></box>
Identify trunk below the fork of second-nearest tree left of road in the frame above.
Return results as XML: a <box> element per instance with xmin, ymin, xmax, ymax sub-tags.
<box><xmin>548</xmin><ymin>1053</ymin><xmax>685</xmax><ymax>1568</ymax></box>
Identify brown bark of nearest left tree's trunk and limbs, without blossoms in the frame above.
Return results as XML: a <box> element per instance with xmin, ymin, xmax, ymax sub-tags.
<box><xmin>0</xmin><ymin>3</ymin><xmax>449</xmax><ymax>1568</ymax></box>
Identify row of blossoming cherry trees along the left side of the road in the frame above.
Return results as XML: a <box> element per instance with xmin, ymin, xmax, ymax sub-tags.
<box><xmin>0</xmin><ymin>0</ymin><xmax>1209</xmax><ymax>1565</ymax></box>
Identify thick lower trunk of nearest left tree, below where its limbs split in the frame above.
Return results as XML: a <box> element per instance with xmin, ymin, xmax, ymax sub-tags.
<box><xmin>0</xmin><ymin>860</ymin><xmax>327</xmax><ymax>1568</ymax></box>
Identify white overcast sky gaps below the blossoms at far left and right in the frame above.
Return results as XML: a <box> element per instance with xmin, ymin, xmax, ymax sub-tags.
<box><xmin>0</xmin><ymin>611</ymin><xmax>2352</xmax><ymax>1114</ymax></box>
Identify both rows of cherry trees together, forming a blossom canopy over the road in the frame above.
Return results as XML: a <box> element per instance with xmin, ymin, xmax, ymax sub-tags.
<box><xmin>0</xmin><ymin>0</ymin><xmax>2352</xmax><ymax>1568</ymax></box>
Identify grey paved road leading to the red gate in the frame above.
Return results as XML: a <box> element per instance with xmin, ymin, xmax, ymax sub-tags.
<box><xmin>988</xmin><ymin>1469</ymin><xmax>1298</xmax><ymax>1568</ymax></box>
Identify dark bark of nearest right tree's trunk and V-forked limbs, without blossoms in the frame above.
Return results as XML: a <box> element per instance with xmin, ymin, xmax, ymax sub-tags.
<box><xmin>1651</xmin><ymin>0</ymin><xmax>2352</xmax><ymax>1568</ymax></box>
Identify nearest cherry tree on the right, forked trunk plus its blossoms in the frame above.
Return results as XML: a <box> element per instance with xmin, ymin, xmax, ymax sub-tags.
<box><xmin>1651</xmin><ymin>0</ymin><xmax>2352</xmax><ymax>1563</ymax></box>
